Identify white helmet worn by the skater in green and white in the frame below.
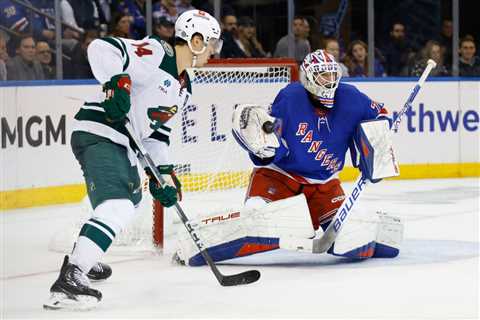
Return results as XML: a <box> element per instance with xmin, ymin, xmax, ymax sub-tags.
<box><xmin>175</xmin><ymin>10</ymin><xmax>222</xmax><ymax>55</ymax></box>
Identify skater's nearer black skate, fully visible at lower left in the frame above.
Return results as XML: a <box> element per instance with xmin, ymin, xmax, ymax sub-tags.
<box><xmin>43</xmin><ymin>256</ymin><xmax>102</xmax><ymax>310</ymax></box>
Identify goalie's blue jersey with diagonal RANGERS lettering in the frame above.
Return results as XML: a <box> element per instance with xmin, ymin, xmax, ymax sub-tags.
<box><xmin>250</xmin><ymin>82</ymin><xmax>386</xmax><ymax>183</ymax></box>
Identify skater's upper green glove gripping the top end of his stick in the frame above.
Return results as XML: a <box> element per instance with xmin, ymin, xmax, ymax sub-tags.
<box><xmin>100</xmin><ymin>73</ymin><xmax>132</xmax><ymax>122</ymax></box>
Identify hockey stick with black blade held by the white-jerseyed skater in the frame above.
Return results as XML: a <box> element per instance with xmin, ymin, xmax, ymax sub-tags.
<box><xmin>125</xmin><ymin>120</ymin><xmax>260</xmax><ymax>287</ymax></box>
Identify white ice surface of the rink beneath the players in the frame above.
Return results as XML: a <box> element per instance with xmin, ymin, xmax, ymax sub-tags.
<box><xmin>0</xmin><ymin>178</ymin><xmax>480</xmax><ymax>319</ymax></box>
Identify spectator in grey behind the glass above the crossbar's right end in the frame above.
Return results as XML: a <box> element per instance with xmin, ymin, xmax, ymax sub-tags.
<box><xmin>274</xmin><ymin>17</ymin><xmax>311</xmax><ymax>64</ymax></box>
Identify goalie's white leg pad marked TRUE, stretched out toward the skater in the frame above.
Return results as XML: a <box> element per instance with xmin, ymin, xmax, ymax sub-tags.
<box><xmin>177</xmin><ymin>194</ymin><xmax>315</xmax><ymax>265</ymax></box>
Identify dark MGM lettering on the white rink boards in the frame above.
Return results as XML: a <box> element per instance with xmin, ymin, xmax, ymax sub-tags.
<box><xmin>0</xmin><ymin>115</ymin><xmax>66</xmax><ymax>149</ymax></box>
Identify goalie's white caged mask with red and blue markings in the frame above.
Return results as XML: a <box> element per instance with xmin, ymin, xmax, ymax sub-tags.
<box><xmin>300</xmin><ymin>50</ymin><xmax>342</xmax><ymax>108</ymax></box>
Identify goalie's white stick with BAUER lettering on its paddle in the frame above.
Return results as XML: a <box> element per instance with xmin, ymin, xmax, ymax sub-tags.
<box><xmin>312</xmin><ymin>59</ymin><xmax>437</xmax><ymax>253</ymax></box>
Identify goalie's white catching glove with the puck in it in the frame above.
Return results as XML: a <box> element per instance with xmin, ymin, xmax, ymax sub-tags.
<box><xmin>232</xmin><ymin>104</ymin><xmax>281</xmax><ymax>159</ymax></box>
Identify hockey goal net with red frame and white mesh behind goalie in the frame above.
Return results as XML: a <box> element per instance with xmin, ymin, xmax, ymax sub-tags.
<box><xmin>50</xmin><ymin>59</ymin><xmax>298</xmax><ymax>253</ymax></box>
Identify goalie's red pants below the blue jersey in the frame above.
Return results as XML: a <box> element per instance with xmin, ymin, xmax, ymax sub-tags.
<box><xmin>247</xmin><ymin>168</ymin><xmax>345</xmax><ymax>230</ymax></box>
